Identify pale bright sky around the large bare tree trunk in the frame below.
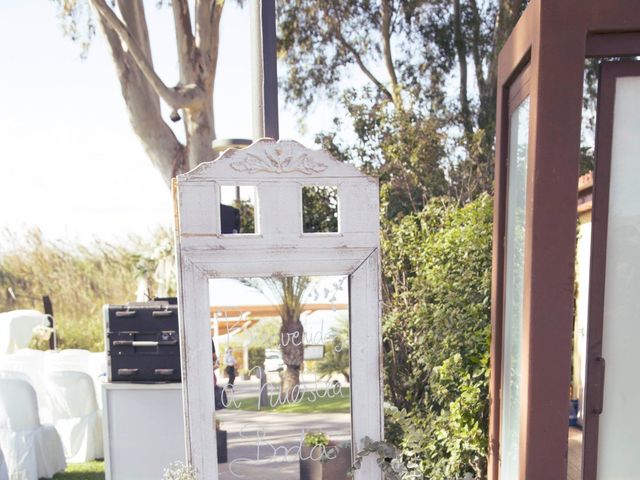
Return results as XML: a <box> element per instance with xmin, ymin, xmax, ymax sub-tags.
<box><xmin>0</xmin><ymin>0</ymin><xmax>333</xmax><ymax>241</ymax></box>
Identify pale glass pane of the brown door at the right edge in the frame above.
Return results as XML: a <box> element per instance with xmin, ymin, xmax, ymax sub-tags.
<box><xmin>597</xmin><ymin>72</ymin><xmax>640</xmax><ymax>480</ymax></box>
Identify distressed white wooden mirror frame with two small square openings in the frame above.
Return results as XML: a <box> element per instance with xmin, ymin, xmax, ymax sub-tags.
<box><xmin>174</xmin><ymin>139</ymin><xmax>383</xmax><ymax>480</ymax></box>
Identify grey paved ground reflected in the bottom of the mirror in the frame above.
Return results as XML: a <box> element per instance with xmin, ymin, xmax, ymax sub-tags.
<box><xmin>217</xmin><ymin>410</ymin><xmax>351</xmax><ymax>480</ymax></box>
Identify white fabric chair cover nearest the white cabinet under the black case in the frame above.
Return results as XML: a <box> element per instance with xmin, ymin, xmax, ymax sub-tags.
<box><xmin>47</xmin><ymin>371</ymin><xmax>103</xmax><ymax>463</ymax></box>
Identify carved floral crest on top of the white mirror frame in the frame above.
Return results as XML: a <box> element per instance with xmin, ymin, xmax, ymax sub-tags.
<box><xmin>231</xmin><ymin>147</ymin><xmax>327</xmax><ymax>175</ymax></box>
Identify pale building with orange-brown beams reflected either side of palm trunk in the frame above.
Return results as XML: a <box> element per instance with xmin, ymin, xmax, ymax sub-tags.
<box><xmin>209</xmin><ymin>276</ymin><xmax>348</xmax><ymax>369</ymax></box>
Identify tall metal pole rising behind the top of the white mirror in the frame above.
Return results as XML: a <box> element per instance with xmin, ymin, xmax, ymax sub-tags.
<box><xmin>251</xmin><ymin>0</ymin><xmax>280</xmax><ymax>140</ymax></box>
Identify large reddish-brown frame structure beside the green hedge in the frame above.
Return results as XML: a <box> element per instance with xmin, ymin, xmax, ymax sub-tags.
<box><xmin>489</xmin><ymin>0</ymin><xmax>640</xmax><ymax>480</ymax></box>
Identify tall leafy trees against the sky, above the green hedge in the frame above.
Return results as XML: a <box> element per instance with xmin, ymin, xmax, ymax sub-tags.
<box><xmin>278</xmin><ymin>0</ymin><xmax>527</xmax><ymax>204</ymax></box>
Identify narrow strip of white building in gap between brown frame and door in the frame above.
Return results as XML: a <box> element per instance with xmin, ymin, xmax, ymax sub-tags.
<box><xmin>571</xmin><ymin>172</ymin><xmax>593</xmax><ymax>425</ymax></box>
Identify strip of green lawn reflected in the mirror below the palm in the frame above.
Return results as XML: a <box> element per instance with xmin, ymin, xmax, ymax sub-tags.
<box><xmin>227</xmin><ymin>387</ymin><xmax>351</xmax><ymax>413</ymax></box>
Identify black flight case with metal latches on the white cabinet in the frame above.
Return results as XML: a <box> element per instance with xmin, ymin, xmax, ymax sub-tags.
<box><xmin>104</xmin><ymin>300</ymin><xmax>181</xmax><ymax>383</ymax></box>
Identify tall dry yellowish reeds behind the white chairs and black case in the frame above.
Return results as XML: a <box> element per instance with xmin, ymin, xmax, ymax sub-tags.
<box><xmin>0</xmin><ymin>230</ymin><xmax>175</xmax><ymax>351</ymax></box>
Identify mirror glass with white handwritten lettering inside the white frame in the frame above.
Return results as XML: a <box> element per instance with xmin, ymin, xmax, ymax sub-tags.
<box><xmin>209</xmin><ymin>276</ymin><xmax>351</xmax><ymax>480</ymax></box>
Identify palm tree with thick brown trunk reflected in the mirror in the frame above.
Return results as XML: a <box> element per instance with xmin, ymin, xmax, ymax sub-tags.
<box><xmin>240</xmin><ymin>277</ymin><xmax>311</xmax><ymax>399</ymax></box>
